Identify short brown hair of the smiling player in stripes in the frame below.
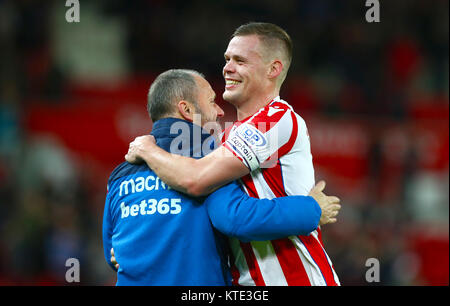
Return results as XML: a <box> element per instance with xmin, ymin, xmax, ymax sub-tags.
<box><xmin>232</xmin><ymin>22</ymin><xmax>292</xmax><ymax>79</ymax></box>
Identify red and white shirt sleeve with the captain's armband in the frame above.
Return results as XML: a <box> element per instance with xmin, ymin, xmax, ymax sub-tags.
<box><xmin>223</xmin><ymin>106</ymin><xmax>296</xmax><ymax>171</ymax></box>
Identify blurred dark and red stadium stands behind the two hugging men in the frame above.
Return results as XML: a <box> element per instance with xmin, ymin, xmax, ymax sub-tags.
<box><xmin>0</xmin><ymin>0</ymin><xmax>449</xmax><ymax>286</ymax></box>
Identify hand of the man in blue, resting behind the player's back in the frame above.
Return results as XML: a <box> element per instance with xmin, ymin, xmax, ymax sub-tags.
<box><xmin>309</xmin><ymin>181</ymin><xmax>341</xmax><ymax>225</ymax></box>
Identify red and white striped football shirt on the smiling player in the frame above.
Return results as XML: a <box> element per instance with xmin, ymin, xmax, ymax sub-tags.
<box><xmin>222</xmin><ymin>97</ymin><xmax>340</xmax><ymax>286</ymax></box>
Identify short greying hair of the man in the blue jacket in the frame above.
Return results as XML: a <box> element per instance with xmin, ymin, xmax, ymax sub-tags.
<box><xmin>147</xmin><ymin>69</ymin><xmax>203</xmax><ymax>122</ymax></box>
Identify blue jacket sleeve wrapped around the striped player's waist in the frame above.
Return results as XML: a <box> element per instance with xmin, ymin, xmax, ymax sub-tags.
<box><xmin>204</xmin><ymin>182</ymin><xmax>322</xmax><ymax>242</ymax></box>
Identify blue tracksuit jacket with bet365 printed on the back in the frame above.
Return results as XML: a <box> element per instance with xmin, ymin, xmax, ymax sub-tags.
<box><xmin>103</xmin><ymin>118</ymin><xmax>321</xmax><ymax>286</ymax></box>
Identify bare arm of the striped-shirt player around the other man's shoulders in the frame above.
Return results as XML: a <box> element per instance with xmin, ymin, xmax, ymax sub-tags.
<box><xmin>125</xmin><ymin>135</ymin><xmax>250</xmax><ymax>196</ymax></box>
